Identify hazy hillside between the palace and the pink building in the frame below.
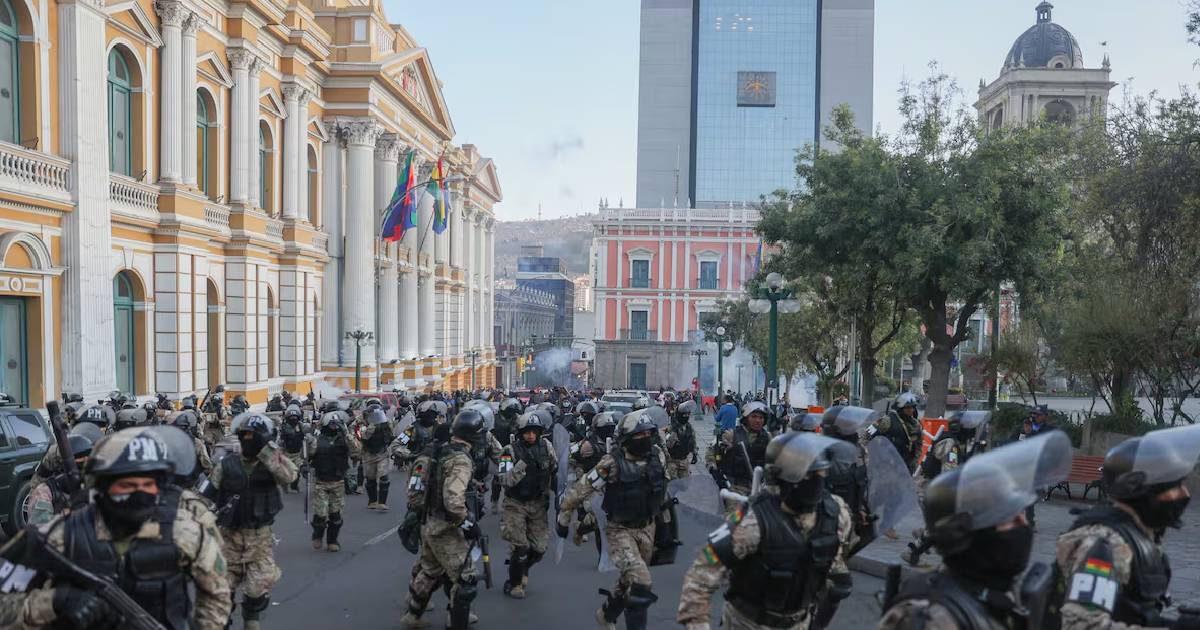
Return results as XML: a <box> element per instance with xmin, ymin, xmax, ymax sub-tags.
<box><xmin>496</xmin><ymin>214</ymin><xmax>595</xmax><ymax>280</ymax></box>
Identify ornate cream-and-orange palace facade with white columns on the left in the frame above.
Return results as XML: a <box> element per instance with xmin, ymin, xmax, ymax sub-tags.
<box><xmin>0</xmin><ymin>0</ymin><xmax>500</xmax><ymax>403</ymax></box>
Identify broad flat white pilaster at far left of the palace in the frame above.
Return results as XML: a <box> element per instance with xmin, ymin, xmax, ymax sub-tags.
<box><xmin>58</xmin><ymin>0</ymin><xmax>116</xmax><ymax>400</ymax></box>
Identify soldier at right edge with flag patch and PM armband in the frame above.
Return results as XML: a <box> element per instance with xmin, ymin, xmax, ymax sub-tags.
<box><xmin>1056</xmin><ymin>426</ymin><xmax>1200</xmax><ymax>630</ymax></box>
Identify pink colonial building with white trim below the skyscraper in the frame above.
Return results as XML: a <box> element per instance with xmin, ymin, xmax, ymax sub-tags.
<box><xmin>592</xmin><ymin>206</ymin><xmax>760</xmax><ymax>389</ymax></box>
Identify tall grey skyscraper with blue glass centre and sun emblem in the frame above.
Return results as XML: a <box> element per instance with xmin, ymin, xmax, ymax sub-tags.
<box><xmin>637</xmin><ymin>0</ymin><xmax>875</xmax><ymax>208</ymax></box>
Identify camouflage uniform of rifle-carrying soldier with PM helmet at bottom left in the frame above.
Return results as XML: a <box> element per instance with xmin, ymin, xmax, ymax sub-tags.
<box><xmin>0</xmin><ymin>487</ymin><xmax>232</xmax><ymax>630</ymax></box>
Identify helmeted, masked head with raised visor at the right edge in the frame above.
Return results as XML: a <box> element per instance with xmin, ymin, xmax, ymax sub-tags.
<box><xmin>1099</xmin><ymin>425</ymin><xmax>1200</xmax><ymax>529</ymax></box>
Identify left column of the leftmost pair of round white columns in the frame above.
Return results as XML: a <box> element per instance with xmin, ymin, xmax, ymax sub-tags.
<box><xmin>155</xmin><ymin>0</ymin><xmax>184</xmax><ymax>181</ymax></box>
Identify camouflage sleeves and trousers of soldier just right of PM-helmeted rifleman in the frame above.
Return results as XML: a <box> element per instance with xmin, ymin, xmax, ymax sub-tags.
<box><xmin>209</xmin><ymin>444</ymin><xmax>299</xmax><ymax>607</ymax></box>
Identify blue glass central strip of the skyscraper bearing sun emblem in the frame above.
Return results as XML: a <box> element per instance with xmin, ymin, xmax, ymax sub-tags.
<box><xmin>690</xmin><ymin>0</ymin><xmax>820</xmax><ymax>206</ymax></box>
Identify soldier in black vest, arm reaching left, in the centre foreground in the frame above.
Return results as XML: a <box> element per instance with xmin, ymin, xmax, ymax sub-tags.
<box><xmin>557</xmin><ymin>410</ymin><xmax>667</xmax><ymax>630</ymax></box>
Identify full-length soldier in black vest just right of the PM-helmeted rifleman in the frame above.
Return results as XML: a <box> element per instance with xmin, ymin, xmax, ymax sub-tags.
<box><xmin>206</xmin><ymin>413</ymin><xmax>298</xmax><ymax>630</ymax></box>
